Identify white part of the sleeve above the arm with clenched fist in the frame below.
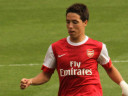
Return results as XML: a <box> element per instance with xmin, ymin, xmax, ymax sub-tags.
<box><xmin>43</xmin><ymin>45</ymin><xmax>56</xmax><ymax>68</ymax></box>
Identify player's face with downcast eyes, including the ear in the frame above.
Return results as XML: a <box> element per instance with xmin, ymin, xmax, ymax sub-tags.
<box><xmin>66</xmin><ymin>12</ymin><xmax>87</xmax><ymax>38</ymax></box>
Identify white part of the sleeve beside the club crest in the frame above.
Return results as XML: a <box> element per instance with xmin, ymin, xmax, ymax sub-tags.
<box><xmin>97</xmin><ymin>44</ymin><xmax>110</xmax><ymax>65</ymax></box>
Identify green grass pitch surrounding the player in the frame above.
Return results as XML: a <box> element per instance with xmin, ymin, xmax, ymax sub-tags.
<box><xmin>0</xmin><ymin>0</ymin><xmax>128</xmax><ymax>96</ymax></box>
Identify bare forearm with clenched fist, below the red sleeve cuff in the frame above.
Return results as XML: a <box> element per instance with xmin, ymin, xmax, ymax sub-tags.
<box><xmin>20</xmin><ymin>71</ymin><xmax>52</xmax><ymax>89</ymax></box>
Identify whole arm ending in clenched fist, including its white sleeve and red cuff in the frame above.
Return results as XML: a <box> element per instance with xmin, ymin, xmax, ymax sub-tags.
<box><xmin>20</xmin><ymin>45</ymin><xmax>56</xmax><ymax>89</ymax></box>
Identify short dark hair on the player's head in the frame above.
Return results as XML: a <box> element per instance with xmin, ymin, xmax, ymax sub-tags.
<box><xmin>66</xmin><ymin>3</ymin><xmax>89</xmax><ymax>22</ymax></box>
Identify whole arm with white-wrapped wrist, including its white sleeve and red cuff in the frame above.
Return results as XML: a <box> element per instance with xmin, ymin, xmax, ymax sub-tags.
<box><xmin>97</xmin><ymin>44</ymin><xmax>128</xmax><ymax>96</ymax></box>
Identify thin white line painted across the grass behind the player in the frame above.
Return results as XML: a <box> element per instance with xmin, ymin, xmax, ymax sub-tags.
<box><xmin>0</xmin><ymin>60</ymin><xmax>128</xmax><ymax>67</ymax></box>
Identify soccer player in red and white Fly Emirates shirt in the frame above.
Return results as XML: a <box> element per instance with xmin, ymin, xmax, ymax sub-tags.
<box><xmin>20</xmin><ymin>3</ymin><xmax>128</xmax><ymax>96</ymax></box>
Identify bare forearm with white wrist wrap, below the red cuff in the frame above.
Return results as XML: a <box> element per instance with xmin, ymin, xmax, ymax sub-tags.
<box><xmin>105</xmin><ymin>65</ymin><xmax>128</xmax><ymax>96</ymax></box>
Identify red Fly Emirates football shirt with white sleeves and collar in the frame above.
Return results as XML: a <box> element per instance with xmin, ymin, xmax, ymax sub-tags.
<box><xmin>42</xmin><ymin>36</ymin><xmax>112</xmax><ymax>96</ymax></box>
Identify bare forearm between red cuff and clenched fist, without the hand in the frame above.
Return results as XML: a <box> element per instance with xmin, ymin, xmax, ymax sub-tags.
<box><xmin>31</xmin><ymin>72</ymin><xmax>51</xmax><ymax>85</ymax></box>
